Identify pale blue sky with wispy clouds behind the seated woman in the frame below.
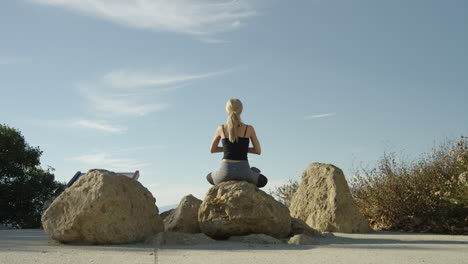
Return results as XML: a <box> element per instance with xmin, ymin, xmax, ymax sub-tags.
<box><xmin>0</xmin><ymin>0</ymin><xmax>468</xmax><ymax>206</ymax></box>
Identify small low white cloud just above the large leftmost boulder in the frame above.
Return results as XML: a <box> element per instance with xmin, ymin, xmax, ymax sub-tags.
<box><xmin>65</xmin><ymin>152</ymin><xmax>149</xmax><ymax>171</ymax></box>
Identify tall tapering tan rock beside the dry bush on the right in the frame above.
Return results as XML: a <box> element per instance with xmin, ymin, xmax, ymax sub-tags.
<box><xmin>289</xmin><ymin>163</ymin><xmax>372</xmax><ymax>233</ymax></box>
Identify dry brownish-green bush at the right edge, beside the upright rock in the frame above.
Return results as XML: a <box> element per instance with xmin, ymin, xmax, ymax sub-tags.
<box><xmin>351</xmin><ymin>136</ymin><xmax>468</xmax><ymax>234</ymax></box>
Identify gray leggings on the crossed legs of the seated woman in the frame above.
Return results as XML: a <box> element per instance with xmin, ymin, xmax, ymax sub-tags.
<box><xmin>206</xmin><ymin>160</ymin><xmax>268</xmax><ymax>187</ymax></box>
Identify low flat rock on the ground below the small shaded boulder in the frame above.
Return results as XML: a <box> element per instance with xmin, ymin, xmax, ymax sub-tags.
<box><xmin>145</xmin><ymin>232</ymin><xmax>216</xmax><ymax>246</ymax></box>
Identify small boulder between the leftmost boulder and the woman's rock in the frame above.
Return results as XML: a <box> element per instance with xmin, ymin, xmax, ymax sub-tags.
<box><xmin>164</xmin><ymin>195</ymin><xmax>202</xmax><ymax>233</ymax></box>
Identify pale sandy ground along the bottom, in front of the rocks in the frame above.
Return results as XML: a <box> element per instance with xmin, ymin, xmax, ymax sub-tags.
<box><xmin>0</xmin><ymin>229</ymin><xmax>468</xmax><ymax>264</ymax></box>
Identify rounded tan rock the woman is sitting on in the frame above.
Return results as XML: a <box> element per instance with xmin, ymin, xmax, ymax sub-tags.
<box><xmin>198</xmin><ymin>181</ymin><xmax>291</xmax><ymax>238</ymax></box>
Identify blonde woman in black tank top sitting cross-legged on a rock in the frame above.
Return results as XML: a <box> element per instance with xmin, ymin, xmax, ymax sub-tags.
<box><xmin>206</xmin><ymin>99</ymin><xmax>268</xmax><ymax>187</ymax></box>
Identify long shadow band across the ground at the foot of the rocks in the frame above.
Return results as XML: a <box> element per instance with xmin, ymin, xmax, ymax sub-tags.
<box><xmin>0</xmin><ymin>229</ymin><xmax>468</xmax><ymax>252</ymax></box>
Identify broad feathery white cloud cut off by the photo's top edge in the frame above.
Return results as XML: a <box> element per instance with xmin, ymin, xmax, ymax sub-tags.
<box><xmin>29</xmin><ymin>0</ymin><xmax>257</xmax><ymax>36</ymax></box>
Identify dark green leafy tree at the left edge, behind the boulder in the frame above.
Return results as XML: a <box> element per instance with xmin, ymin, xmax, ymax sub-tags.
<box><xmin>0</xmin><ymin>125</ymin><xmax>65</xmax><ymax>228</ymax></box>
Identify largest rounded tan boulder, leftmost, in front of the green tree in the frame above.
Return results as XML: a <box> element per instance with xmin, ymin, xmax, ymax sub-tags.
<box><xmin>42</xmin><ymin>170</ymin><xmax>164</xmax><ymax>244</ymax></box>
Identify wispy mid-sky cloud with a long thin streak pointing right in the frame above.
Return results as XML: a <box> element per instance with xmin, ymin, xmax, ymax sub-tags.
<box><xmin>76</xmin><ymin>69</ymin><xmax>234</xmax><ymax>117</ymax></box>
